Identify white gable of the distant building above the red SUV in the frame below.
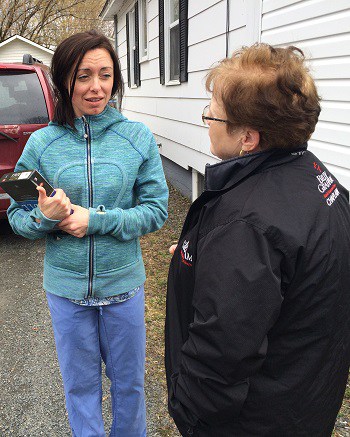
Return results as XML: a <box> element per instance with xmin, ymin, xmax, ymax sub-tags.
<box><xmin>0</xmin><ymin>39</ymin><xmax>52</xmax><ymax>66</ymax></box>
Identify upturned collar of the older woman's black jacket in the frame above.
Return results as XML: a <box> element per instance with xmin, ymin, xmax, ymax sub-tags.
<box><xmin>205</xmin><ymin>144</ymin><xmax>307</xmax><ymax>191</ymax></box>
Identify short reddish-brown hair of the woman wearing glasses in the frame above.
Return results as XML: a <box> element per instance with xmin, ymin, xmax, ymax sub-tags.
<box><xmin>206</xmin><ymin>44</ymin><xmax>321</xmax><ymax>149</ymax></box>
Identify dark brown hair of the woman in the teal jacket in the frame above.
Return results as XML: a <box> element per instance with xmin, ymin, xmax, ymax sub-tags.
<box><xmin>51</xmin><ymin>30</ymin><xmax>124</xmax><ymax>127</ymax></box>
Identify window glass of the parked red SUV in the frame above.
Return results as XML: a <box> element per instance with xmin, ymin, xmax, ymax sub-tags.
<box><xmin>0</xmin><ymin>70</ymin><xmax>49</xmax><ymax>125</ymax></box>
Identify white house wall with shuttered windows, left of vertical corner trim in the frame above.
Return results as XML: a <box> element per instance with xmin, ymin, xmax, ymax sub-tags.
<box><xmin>117</xmin><ymin>0</ymin><xmax>262</xmax><ymax>196</ymax></box>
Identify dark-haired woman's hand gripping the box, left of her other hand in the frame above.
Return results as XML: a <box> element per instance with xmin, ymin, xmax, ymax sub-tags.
<box><xmin>36</xmin><ymin>186</ymin><xmax>72</xmax><ymax>220</ymax></box>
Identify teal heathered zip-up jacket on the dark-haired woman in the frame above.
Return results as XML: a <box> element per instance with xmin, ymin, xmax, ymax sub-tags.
<box><xmin>8</xmin><ymin>106</ymin><xmax>168</xmax><ymax>299</ymax></box>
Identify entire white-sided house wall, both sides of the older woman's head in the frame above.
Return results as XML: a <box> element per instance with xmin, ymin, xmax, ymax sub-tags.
<box><xmin>113</xmin><ymin>0</ymin><xmax>350</xmax><ymax>196</ymax></box>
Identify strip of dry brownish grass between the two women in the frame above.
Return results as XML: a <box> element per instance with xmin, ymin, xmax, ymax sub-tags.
<box><xmin>141</xmin><ymin>182</ymin><xmax>190</xmax><ymax>437</ymax></box>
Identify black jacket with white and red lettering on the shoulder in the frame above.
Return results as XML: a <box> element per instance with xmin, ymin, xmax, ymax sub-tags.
<box><xmin>165</xmin><ymin>146</ymin><xmax>350</xmax><ymax>437</ymax></box>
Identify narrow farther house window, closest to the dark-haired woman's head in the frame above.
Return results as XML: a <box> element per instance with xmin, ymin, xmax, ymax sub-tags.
<box><xmin>126</xmin><ymin>2</ymin><xmax>141</xmax><ymax>88</ymax></box>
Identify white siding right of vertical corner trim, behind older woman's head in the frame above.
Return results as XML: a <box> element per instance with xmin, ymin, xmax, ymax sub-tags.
<box><xmin>261</xmin><ymin>0</ymin><xmax>350</xmax><ymax>189</ymax></box>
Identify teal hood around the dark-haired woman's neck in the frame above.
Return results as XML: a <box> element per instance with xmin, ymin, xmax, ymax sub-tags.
<box><xmin>49</xmin><ymin>105</ymin><xmax>127</xmax><ymax>141</ymax></box>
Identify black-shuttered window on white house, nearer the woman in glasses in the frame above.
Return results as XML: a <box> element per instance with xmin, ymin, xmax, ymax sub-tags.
<box><xmin>159</xmin><ymin>0</ymin><xmax>188</xmax><ymax>85</ymax></box>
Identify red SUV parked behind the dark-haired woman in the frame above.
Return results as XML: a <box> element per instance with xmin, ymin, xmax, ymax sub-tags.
<box><xmin>0</xmin><ymin>55</ymin><xmax>54</xmax><ymax>220</ymax></box>
